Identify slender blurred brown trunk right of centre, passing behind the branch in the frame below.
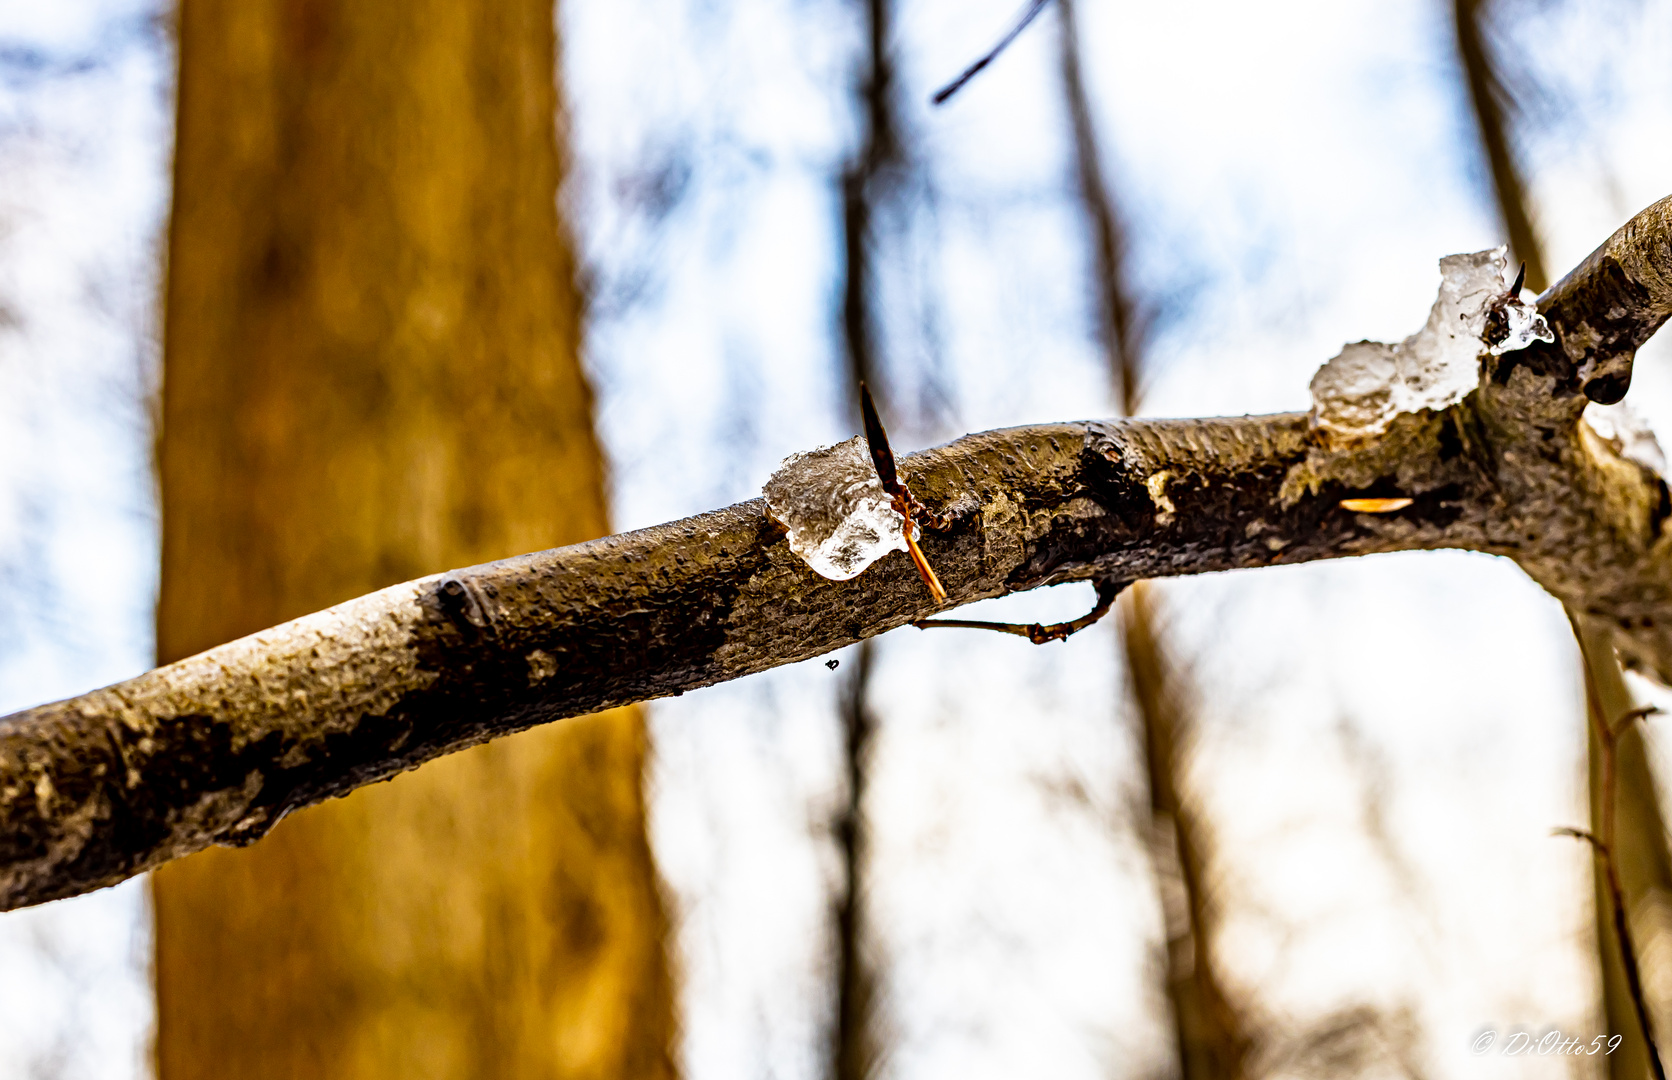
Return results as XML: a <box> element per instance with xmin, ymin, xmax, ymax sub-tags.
<box><xmin>1057</xmin><ymin>0</ymin><xmax>1254</xmax><ymax>1080</ymax></box>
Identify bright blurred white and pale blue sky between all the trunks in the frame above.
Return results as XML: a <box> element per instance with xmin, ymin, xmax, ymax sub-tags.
<box><xmin>0</xmin><ymin>0</ymin><xmax>1672</xmax><ymax>1078</ymax></box>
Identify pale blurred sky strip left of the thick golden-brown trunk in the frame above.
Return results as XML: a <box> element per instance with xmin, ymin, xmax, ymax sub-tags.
<box><xmin>0</xmin><ymin>0</ymin><xmax>172</xmax><ymax>1080</ymax></box>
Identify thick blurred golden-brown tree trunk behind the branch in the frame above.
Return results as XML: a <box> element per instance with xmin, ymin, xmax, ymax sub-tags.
<box><xmin>154</xmin><ymin>0</ymin><xmax>674</xmax><ymax>1080</ymax></box>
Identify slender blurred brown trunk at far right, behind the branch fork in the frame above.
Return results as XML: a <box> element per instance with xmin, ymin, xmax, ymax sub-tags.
<box><xmin>1453</xmin><ymin>0</ymin><xmax>1672</xmax><ymax>1080</ymax></box>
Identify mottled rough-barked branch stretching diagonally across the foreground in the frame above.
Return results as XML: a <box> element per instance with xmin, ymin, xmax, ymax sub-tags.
<box><xmin>0</xmin><ymin>197</ymin><xmax>1672</xmax><ymax>909</ymax></box>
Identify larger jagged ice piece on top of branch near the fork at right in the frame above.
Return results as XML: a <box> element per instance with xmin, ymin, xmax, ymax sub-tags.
<box><xmin>1313</xmin><ymin>247</ymin><xmax>1555</xmax><ymax>438</ymax></box>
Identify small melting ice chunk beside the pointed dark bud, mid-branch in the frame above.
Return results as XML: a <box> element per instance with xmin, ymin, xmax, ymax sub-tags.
<box><xmin>761</xmin><ymin>435</ymin><xmax>906</xmax><ymax>582</ymax></box>
